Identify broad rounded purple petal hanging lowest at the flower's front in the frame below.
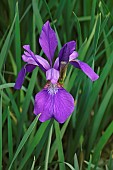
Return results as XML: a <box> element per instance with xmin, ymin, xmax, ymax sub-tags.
<box><xmin>34</xmin><ymin>84</ymin><xmax>74</xmax><ymax>123</ymax></box>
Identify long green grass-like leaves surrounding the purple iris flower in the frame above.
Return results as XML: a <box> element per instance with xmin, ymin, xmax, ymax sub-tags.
<box><xmin>0</xmin><ymin>0</ymin><xmax>113</xmax><ymax>170</ymax></box>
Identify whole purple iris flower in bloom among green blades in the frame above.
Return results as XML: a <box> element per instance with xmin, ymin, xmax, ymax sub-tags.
<box><xmin>14</xmin><ymin>21</ymin><xmax>99</xmax><ymax>123</ymax></box>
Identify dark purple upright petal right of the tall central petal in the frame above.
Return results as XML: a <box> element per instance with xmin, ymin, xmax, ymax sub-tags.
<box><xmin>58</xmin><ymin>41</ymin><xmax>76</xmax><ymax>63</ymax></box>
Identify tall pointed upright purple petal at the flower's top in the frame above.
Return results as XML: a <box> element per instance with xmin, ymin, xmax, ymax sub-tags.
<box><xmin>39</xmin><ymin>21</ymin><xmax>58</xmax><ymax>65</ymax></box>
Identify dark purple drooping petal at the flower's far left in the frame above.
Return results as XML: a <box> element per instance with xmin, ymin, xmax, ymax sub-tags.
<box><xmin>14</xmin><ymin>64</ymin><xmax>36</xmax><ymax>89</ymax></box>
